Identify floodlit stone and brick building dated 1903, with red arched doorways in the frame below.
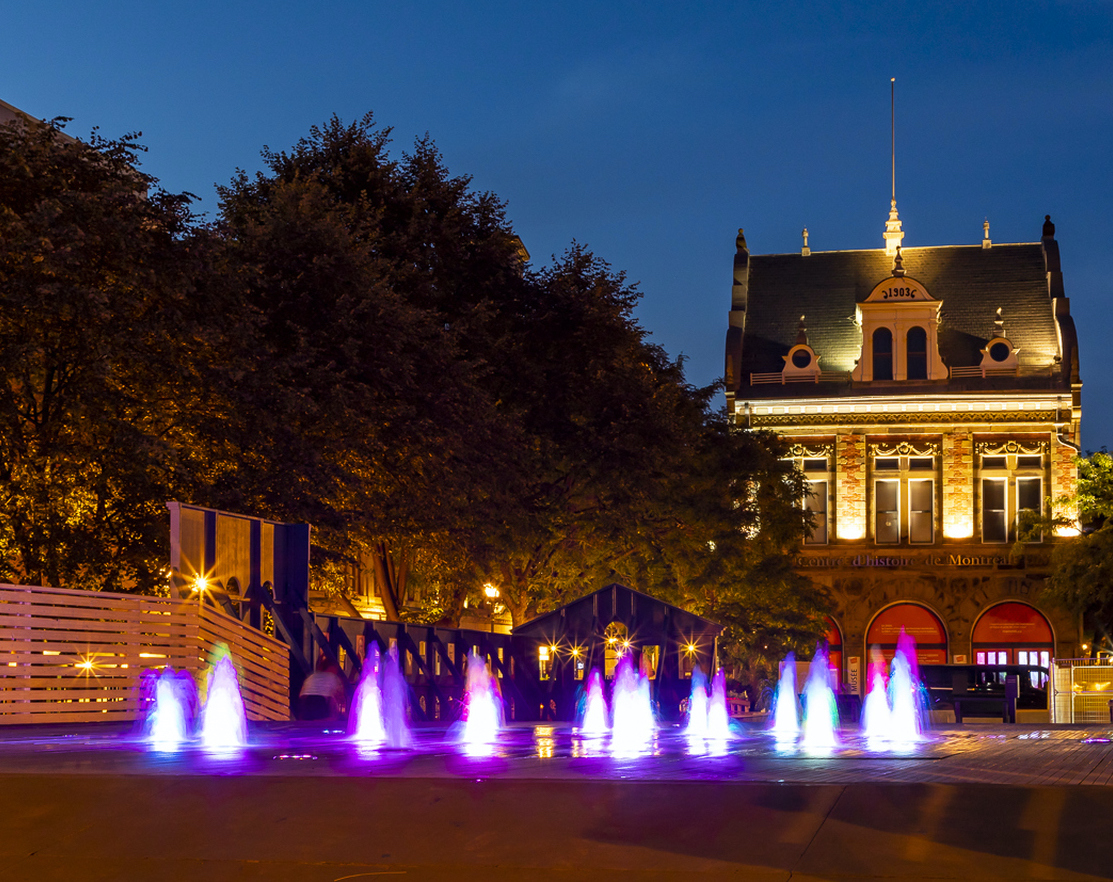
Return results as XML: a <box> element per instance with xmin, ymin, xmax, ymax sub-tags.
<box><xmin>726</xmin><ymin>210</ymin><xmax>1082</xmax><ymax>690</ymax></box>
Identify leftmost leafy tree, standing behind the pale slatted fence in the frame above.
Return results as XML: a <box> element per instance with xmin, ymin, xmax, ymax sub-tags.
<box><xmin>0</xmin><ymin>113</ymin><xmax>206</xmax><ymax>590</ymax></box>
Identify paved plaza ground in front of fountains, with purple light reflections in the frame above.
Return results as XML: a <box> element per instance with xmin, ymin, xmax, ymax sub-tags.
<box><xmin>0</xmin><ymin>724</ymin><xmax>1113</xmax><ymax>882</ymax></box>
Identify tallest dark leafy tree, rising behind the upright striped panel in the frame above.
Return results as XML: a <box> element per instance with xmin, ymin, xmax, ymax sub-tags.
<box><xmin>214</xmin><ymin>115</ymin><xmax>521</xmax><ymax>619</ymax></box>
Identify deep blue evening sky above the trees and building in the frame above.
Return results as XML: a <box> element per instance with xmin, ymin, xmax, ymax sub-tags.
<box><xmin>8</xmin><ymin>0</ymin><xmax>1113</xmax><ymax>448</ymax></box>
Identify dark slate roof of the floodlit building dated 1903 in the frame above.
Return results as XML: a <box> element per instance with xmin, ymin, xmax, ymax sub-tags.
<box><xmin>737</xmin><ymin>239</ymin><xmax>1073</xmax><ymax>394</ymax></box>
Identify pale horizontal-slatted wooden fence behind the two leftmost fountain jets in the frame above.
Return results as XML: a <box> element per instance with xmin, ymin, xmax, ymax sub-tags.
<box><xmin>0</xmin><ymin>585</ymin><xmax>289</xmax><ymax>724</ymax></box>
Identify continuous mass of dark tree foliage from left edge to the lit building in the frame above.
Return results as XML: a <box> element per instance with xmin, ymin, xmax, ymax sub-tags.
<box><xmin>0</xmin><ymin>115</ymin><xmax>824</xmax><ymax>668</ymax></box>
